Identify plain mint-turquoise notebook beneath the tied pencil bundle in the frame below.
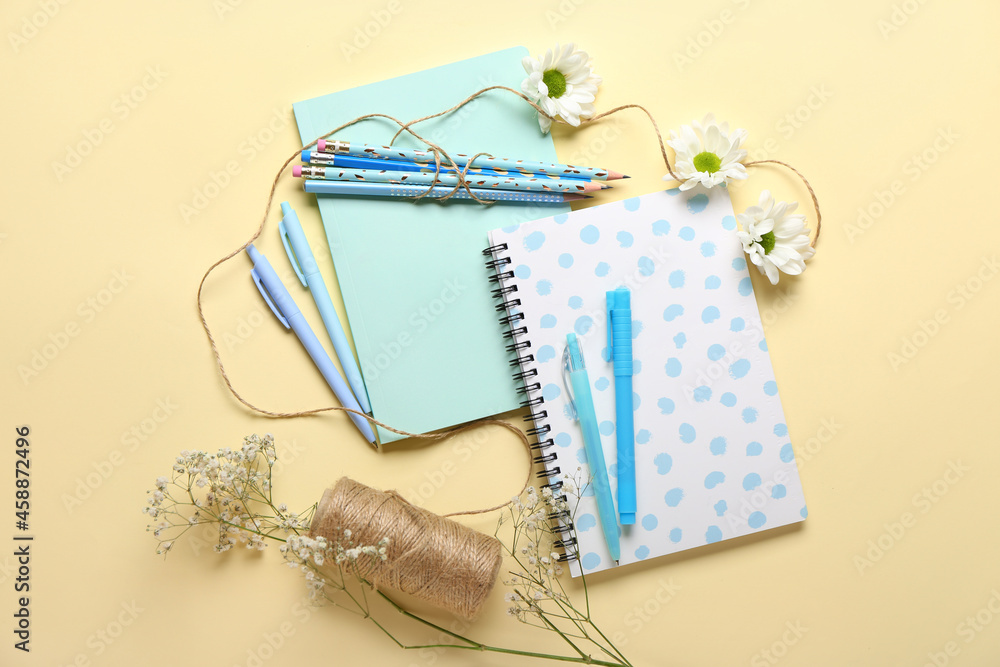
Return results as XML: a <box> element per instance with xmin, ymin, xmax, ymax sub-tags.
<box><xmin>293</xmin><ymin>47</ymin><xmax>569</xmax><ymax>443</ymax></box>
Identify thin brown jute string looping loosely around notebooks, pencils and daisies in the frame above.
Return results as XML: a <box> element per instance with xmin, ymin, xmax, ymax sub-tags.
<box><xmin>198</xmin><ymin>86</ymin><xmax>821</xmax><ymax>516</ymax></box>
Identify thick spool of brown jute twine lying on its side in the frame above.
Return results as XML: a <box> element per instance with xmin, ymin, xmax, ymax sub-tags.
<box><xmin>309</xmin><ymin>477</ymin><xmax>503</xmax><ymax>620</ymax></box>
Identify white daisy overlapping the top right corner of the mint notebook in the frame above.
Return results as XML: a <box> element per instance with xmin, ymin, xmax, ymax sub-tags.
<box><xmin>521</xmin><ymin>44</ymin><xmax>602</xmax><ymax>133</ymax></box>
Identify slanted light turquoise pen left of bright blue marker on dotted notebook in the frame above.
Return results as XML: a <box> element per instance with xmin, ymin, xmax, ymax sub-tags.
<box><xmin>563</xmin><ymin>334</ymin><xmax>621</xmax><ymax>565</ymax></box>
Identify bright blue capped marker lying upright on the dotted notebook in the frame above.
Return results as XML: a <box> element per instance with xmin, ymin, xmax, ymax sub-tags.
<box><xmin>606</xmin><ymin>287</ymin><xmax>636</xmax><ymax>526</ymax></box>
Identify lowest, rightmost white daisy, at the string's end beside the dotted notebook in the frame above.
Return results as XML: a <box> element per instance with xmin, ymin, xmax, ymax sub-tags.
<box><xmin>736</xmin><ymin>190</ymin><xmax>815</xmax><ymax>285</ymax></box>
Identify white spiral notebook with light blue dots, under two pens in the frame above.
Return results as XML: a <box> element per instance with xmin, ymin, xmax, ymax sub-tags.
<box><xmin>487</xmin><ymin>187</ymin><xmax>806</xmax><ymax>576</ymax></box>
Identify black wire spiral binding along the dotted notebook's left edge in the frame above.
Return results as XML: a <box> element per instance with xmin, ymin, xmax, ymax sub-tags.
<box><xmin>483</xmin><ymin>243</ymin><xmax>579</xmax><ymax>562</ymax></box>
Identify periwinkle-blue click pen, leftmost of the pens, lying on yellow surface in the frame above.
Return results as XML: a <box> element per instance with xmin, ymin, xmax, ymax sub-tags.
<box><xmin>247</xmin><ymin>243</ymin><xmax>375</xmax><ymax>444</ymax></box>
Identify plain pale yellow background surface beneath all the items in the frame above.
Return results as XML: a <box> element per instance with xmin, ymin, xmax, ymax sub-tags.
<box><xmin>0</xmin><ymin>0</ymin><xmax>1000</xmax><ymax>666</ymax></box>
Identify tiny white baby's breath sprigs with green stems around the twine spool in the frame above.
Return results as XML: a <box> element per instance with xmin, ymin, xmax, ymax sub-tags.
<box><xmin>142</xmin><ymin>435</ymin><xmax>629</xmax><ymax>667</ymax></box>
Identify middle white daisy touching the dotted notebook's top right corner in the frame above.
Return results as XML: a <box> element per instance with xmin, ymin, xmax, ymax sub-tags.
<box><xmin>663</xmin><ymin>114</ymin><xmax>747</xmax><ymax>190</ymax></box>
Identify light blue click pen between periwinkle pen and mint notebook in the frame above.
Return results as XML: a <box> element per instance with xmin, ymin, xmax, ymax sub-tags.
<box><xmin>278</xmin><ymin>202</ymin><xmax>372</xmax><ymax>413</ymax></box>
